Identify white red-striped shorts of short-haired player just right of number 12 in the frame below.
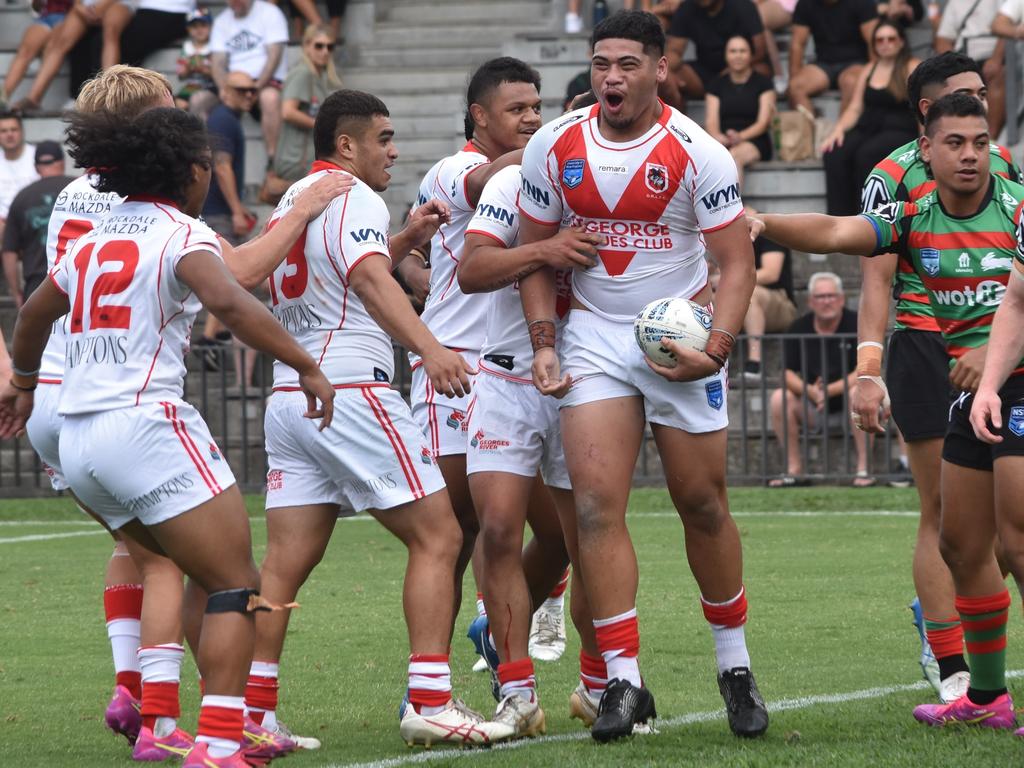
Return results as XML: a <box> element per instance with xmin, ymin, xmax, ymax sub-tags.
<box><xmin>263</xmin><ymin>384</ymin><xmax>444</xmax><ymax>513</ymax></box>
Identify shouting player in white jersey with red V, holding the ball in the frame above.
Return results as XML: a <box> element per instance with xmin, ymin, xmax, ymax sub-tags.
<box><xmin>519</xmin><ymin>11</ymin><xmax>768</xmax><ymax>741</ymax></box>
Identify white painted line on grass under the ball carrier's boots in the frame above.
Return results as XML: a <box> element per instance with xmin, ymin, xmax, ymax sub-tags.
<box><xmin>324</xmin><ymin>670</ymin><xmax>1024</xmax><ymax>768</ymax></box>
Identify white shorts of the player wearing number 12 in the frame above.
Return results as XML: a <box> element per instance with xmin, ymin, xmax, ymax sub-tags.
<box><xmin>60</xmin><ymin>400</ymin><xmax>234</xmax><ymax>529</ymax></box>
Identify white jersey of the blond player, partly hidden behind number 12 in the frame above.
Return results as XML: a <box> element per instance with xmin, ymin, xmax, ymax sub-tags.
<box><xmin>39</xmin><ymin>175</ymin><xmax>124</xmax><ymax>384</ymax></box>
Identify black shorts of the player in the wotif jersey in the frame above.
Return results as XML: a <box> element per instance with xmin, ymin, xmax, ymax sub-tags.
<box><xmin>942</xmin><ymin>376</ymin><xmax>1024</xmax><ymax>472</ymax></box>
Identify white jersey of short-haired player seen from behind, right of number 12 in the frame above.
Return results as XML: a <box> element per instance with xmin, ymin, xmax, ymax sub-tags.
<box><xmin>268</xmin><ymin>161</ymin><xmax>394</xmax><ymax>390</ymax></box>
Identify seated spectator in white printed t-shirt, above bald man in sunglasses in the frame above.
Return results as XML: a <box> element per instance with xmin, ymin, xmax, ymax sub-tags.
<box><xmin>210</xmin><ymin>0</ymin><xmax>288</xmax><ymax>166</ymax></box>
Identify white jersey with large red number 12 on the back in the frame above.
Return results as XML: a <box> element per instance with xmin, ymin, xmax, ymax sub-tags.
<box><xmin>50</xmin><ymin>197</ymin><xmax>220</xmax><ymax>415</ymax></box>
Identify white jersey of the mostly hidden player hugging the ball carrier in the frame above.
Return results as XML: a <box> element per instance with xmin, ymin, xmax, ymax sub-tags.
<box><xmin>466</xmin><ymin>165</ymin><xmax>572</xmax><ymax>384</ymax></box>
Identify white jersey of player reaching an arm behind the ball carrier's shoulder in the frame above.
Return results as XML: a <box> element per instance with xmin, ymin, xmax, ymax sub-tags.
<box><xmin>410</xmin><ymin>143</ymin><xmax>488</xmax><ymax>362</ymax></box>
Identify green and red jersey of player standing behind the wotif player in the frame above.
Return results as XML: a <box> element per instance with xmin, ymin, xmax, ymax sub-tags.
<box><xmin>860</xmin><ymin>139</ymin><xmax>1021</xmax><ymax>331</ymax></box>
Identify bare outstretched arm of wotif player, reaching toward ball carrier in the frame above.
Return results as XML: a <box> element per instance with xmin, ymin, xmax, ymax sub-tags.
<box><xmin>753</xmin><ymin>213</ymin><xmax>879</xmax><ymax>256</ymax></box>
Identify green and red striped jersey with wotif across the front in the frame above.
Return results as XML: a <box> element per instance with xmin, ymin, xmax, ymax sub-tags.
<box><xmin>861</xmin><ymin>176</ymin><xmax>1024</xmax><ymax>374</ymax></box>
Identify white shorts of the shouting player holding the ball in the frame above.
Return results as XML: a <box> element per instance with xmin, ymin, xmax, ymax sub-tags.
<box><xmin>559</xmin><ymin>309</ymin><xmax>729</xmax><ymax>434</ymax></box>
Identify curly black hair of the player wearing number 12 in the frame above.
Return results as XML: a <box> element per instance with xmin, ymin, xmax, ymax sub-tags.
<box><xmin>68</xmin><ymin>108</ymin><xmax>210</xmax><ymax>203</ymax></box>
